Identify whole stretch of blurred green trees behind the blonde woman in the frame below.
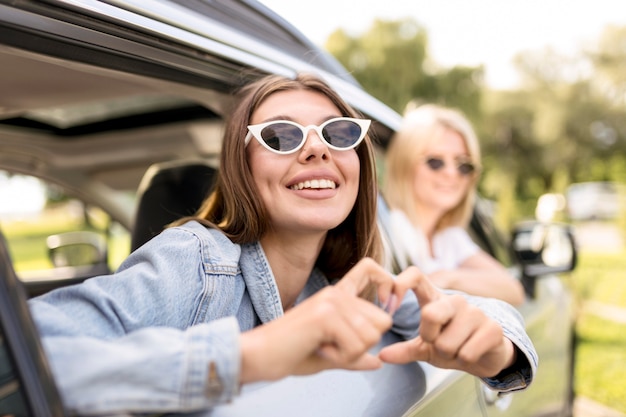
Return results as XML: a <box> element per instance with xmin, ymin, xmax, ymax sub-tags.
<box><xmin>325</xmin><ymin>19</ymin><xmax>626</xmax><ymax>226</ymax></box>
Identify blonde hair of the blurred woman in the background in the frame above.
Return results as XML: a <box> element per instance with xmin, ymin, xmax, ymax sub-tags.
<box><xmin>384</xmin><ymin>104</ymin><xmax>480</xmax><ymax>231</ymax></box>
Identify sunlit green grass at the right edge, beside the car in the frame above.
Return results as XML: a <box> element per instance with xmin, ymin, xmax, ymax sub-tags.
<box><xmin>572</xmin><ymin>245</ymin><xmax>626</xmax><ymax>413</ymax></box>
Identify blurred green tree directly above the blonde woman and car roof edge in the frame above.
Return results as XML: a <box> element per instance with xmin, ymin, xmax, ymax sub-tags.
<box><xmin>325</xmin><ymin>19</ymin><xmax>483</xmax><ymax>119</ymax></box>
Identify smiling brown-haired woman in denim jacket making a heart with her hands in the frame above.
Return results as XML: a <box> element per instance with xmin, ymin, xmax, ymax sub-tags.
<box><xmin>31</xmin><ymin>75</ymin><xmax>537</xmax><ymax>414</ymax></box>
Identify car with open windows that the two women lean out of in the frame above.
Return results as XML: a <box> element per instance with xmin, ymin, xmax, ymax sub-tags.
<box><xmin>0</xmin><ymin>0</ymin><xmax>576</xmax><ymax>417</ymax></box>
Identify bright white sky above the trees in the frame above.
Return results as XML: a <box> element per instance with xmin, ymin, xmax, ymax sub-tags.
<box><xmin>260</xmin><ymin>0</ymin><xmax>626</xmax><ymax>88</ymax></box>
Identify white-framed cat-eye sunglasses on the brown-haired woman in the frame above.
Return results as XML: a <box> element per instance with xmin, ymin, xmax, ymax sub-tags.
<box><xmin>245</xmin><ymin>117</ymin><xmax>371</xmax><ymax>155</ymax></box>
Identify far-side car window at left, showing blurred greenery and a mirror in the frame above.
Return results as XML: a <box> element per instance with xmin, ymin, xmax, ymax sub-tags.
<box><xmin>0</xmin><ymin>171</ymin><xmax>130</xmax><ymax>288</ymax></box>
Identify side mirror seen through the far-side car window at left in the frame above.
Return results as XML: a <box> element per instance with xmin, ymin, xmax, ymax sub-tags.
<box><xmin>46</xmin><ymin>231</ymin><xmax>108</xmax><ymax>270</ymax></box>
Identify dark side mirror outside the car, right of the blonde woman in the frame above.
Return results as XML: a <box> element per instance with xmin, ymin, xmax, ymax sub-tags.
<box><xmin>512</xmin><ymin>222</ymin><xmax>577</xmax><ymax>278</ymax></box>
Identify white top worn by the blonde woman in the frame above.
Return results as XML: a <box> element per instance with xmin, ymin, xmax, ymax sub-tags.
<box><xmin>390</xmin><ymin>209</ymin><xmax>480</xmax><ymax>274</ymax></box>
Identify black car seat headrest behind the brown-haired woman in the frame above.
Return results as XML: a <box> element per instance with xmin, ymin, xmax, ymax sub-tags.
<box><xmin>131</xmin><ymin>161</ymin><xmax>217</xmax><ymax>251</ymax></box>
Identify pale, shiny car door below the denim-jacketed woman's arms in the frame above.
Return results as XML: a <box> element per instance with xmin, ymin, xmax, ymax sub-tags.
<box><xmin>176</xmin><ymin>333</ymin><xmax>483</xmax><ymax>417</ymax></box>
